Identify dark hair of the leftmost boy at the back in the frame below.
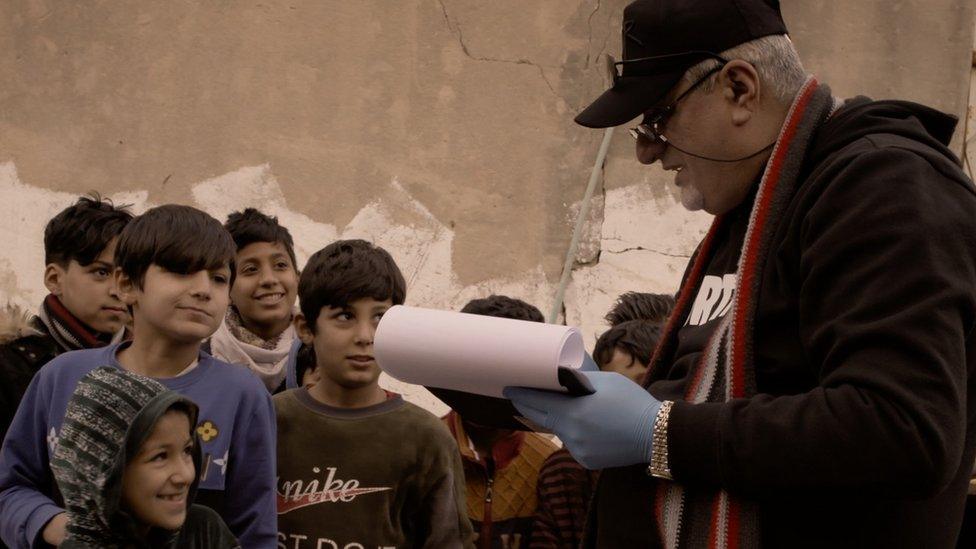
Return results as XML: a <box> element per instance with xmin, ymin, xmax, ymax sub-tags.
<box><xmin>44</xmin><ymin>193</ymin><xmax>132</xmax><ymax>267</ymax></box>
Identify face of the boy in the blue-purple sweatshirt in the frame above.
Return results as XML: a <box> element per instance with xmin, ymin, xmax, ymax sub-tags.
<box><xmin>116</xmin><ymin>264</ymin><xmax>230</xmax><ymax>343</ymax></box>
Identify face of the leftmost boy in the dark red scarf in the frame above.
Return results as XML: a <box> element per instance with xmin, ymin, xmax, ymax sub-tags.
<box><xmin>44</xmin><ymin>238</ymin><xmax>129</xmax><ymax>334</ymax></box>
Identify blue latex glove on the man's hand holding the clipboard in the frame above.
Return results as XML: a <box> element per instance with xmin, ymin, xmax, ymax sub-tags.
<box><xmin>504</xmin><ymin>372</ymin><xmax>661</xmax><ymax>469</ymax></box>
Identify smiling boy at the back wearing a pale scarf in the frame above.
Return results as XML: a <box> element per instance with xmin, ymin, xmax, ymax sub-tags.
<box><xmin>212</xmin><ymin>208</ymin><xmax>298</xmax><ymax>393</ymax></box>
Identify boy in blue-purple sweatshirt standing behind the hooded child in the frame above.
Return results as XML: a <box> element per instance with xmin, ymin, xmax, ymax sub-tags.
<box><xmin>0</xmin><ymin>205</ymin><xmax>275</xmax><ymax>548</ymax></box>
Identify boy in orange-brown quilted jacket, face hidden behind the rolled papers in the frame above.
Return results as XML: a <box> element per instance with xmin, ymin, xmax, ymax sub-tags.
<box><xmin>443</xmin><ymin>295</ymin><xmax>558</xmax><ymax>549</ymax></box>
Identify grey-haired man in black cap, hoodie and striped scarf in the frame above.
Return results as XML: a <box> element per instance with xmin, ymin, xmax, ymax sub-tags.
<box><xmin>506</xmin><ymin>0</ymin><xmax>976</xmax><ymax>548</ymax></box>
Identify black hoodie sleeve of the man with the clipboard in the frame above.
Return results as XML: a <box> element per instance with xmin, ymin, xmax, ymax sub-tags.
<box><xmin>668</xmin><ymin>147</ymin><xmax>976</xmax><ymax>497</ymax></box>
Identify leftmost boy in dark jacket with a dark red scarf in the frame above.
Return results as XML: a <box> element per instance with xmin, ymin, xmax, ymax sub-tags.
<box><xmin>0</xmin><ymin>195</ymin><xmax>132</xmax><ymax>439</ymax></box>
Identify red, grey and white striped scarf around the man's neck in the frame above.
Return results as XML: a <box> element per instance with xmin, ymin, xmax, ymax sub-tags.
<box><xmin>644</xmin><ymin>77</ymin><xmax>834</xmax><ymax>549</ymax></box>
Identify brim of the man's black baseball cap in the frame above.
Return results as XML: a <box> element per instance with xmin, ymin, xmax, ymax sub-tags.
<box><xmin>575</xmin><ymin>70</ymin><xmax>684</xmax><ymax>128</ymax></box>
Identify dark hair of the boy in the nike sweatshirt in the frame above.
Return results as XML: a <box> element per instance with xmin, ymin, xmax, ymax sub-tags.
<box><xmin>298</xmin><ymin>240</ymin><xmax>407</xmax><ymax>333</ymax></box>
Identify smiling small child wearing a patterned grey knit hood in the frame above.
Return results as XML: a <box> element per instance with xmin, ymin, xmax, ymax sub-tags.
<box><xmin>51</xmin><ymin>367</ymin><xmax>240</xmax><ymax>549</ymax></box>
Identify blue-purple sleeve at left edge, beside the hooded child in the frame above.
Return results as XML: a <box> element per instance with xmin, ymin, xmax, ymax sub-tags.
<box><xmin>0</xmin><ymin>370</ymin><xmax>64</xmax><ymax>549</ymax></box>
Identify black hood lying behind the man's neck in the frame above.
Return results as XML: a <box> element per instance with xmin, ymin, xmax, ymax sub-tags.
<box><xmin>808</xmin><ymin>96</ymin><xmax>960</xmax><ymax>166</ymax></box>
